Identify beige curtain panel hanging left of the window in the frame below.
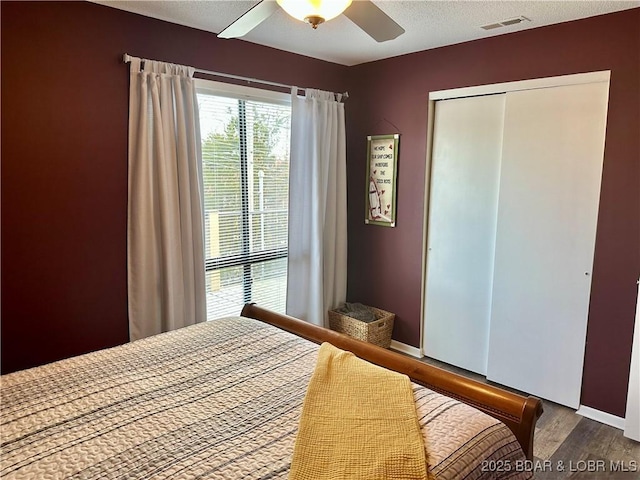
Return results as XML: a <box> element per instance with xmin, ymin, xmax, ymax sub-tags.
<box><xmin>127</xmin><ymin>58</ymin><xmax>206</xmax><ymax>340</ymax></box>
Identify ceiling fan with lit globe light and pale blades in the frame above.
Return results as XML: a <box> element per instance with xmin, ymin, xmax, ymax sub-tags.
<box><xmin>218</xmin><ymin>0</ymin><xmax>404</xmax><ymax>42</ymax></box>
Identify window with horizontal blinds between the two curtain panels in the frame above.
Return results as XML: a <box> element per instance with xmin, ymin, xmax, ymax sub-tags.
<box><xmin>197</xmin><ymin>80</ymin><xmax>291</xmax><ymax>320</ymax></box>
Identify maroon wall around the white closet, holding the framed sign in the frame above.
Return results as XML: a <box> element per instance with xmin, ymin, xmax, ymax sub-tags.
<box><xmin>347</xmin><ymin>9</ymin><xmax>640</xmax><ymax>416</ymax></box>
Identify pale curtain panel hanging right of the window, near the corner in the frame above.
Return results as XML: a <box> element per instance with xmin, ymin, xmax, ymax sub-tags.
<box><xmin>287</xmin><ymin>88</ymin><xmax>347</xmax><ymax>326</ymax></box>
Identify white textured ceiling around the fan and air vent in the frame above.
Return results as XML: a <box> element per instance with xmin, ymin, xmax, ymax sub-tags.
<box><xmin>93</xmin><ymin>0</ymin><xmax>640</xmax><ymax>65</ymax></box>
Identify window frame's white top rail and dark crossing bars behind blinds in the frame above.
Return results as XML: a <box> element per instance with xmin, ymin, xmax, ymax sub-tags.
<box><xmin>194</xmin><ymin>78</ymin><xmax>291</xmax><ymax>303</ymax></box>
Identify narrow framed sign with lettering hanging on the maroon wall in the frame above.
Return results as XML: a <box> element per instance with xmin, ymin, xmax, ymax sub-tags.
<box><xmin>364</xmin><ymin>133</ymin><xmax>400</xmax><ymax>227</ymax></box>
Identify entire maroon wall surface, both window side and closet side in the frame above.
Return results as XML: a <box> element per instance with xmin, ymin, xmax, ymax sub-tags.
<box><xmin>0</xmin><ymin>2</ymin><xmax>640</xmax><ymax>416</ymax></box>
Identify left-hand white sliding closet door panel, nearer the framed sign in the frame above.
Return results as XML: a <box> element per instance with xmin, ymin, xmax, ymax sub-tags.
<box><xmin>423</xmin><ymin>95</ymin><xmax>504</xmax><ymax>374</ymax></box>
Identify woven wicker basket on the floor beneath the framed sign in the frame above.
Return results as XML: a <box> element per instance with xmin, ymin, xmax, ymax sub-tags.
<box><xmin>329</xmin><ymin>307</ymin><xmax>396</xmax><ymax>348</ymax></box>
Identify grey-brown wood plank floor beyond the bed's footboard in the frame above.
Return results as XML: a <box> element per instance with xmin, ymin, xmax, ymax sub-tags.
<box><xmin>422</xmin><ymin>357</ymin><xmax>640</xmax><ymax>480</ymax></box>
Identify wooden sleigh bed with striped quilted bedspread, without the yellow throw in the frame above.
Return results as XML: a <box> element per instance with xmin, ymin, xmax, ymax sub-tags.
<box><xmin>0</xmin><ymin>305</ymin><xmax>542</xmax><ymax>480</ymax></box>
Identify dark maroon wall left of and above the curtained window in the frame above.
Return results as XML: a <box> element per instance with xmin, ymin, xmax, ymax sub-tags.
<box><xmin>0</xmin><ymin>2</ymin><xmax>347</xmax><ymax>373</ymax></box>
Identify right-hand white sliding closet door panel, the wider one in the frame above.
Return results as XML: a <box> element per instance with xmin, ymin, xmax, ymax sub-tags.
<box><xmin>487</xmin><ymin>83</ymin><xmax>608</xmax><ymax>408</ymax></box>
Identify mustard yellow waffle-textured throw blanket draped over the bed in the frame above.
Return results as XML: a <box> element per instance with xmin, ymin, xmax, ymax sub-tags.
<box><xmin>289</xmin><ymin>343</ymin><xmax>427</xmax><ymax>480</ymax></box>
